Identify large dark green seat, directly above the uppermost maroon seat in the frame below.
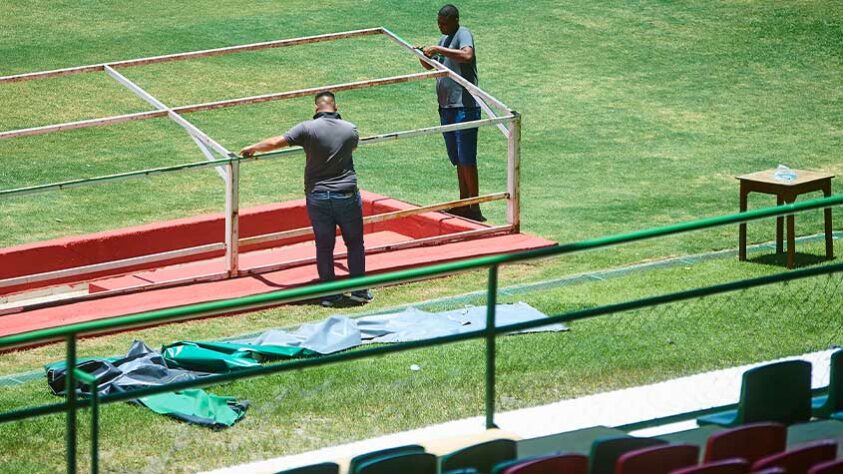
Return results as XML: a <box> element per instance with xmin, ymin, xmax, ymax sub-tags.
<box><xmin>697</xmin><ymin>360</ymin><xmax>811</xmax><ymax>427</ymax></box>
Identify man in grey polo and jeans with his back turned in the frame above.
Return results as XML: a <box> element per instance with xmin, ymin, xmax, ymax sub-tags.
<box><xmin>240</xmin><ymin>92</ymin><xmax>372</xmax><ymax>307</ymax></box>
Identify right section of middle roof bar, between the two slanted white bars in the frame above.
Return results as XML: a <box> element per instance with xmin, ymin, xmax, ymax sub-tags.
<box><xmin>173</xmin><ymin>71</ymin><xmax>447</xmax><ymax>113</ymax></box>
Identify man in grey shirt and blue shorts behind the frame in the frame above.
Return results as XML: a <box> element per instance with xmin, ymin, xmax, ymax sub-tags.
<box><xmin>421</xmin><ymin>4</ymin><xmax>486</xmax><ymax>221</ymax></box>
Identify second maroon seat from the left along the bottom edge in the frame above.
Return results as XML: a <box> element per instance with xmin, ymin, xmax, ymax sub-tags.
<box><xmin>615</xmin><ymin>444</ymin><xmax>700</xmax><ymax>474</ymax></box>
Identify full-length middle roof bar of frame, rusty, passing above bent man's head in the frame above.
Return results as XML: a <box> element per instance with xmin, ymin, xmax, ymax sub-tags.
<box><xmin>0</xmin><ymin>69</ymin><xmax>447</xmax><ymax>140</ymax></box>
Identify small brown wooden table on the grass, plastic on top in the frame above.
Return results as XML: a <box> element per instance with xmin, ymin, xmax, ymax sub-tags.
<box><xmin>737</xmin><ymin>169</ymin><xmax>834</xmax><ymax>268</ymax></box>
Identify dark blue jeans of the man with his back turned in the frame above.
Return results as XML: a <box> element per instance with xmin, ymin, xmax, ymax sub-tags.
<box><xmin>306</xmin><ymin>191</ymin><xmax>366</xmax><ymax>282</ymax></box>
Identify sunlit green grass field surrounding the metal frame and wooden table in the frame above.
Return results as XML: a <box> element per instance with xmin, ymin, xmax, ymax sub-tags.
<box><xmin>0</xmin><ymin>0</ymin><xmax>843</xmax><ymax>473</ymax></box>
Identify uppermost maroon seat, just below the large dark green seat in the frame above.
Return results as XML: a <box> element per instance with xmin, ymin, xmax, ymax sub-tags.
<box><xmin>703</xmin><ymin>423</ymin><xmax>787</xmax><ymax>464</ymax></box>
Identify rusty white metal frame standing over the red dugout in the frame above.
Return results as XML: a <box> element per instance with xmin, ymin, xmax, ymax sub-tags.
<box><xmin>0</xmin><ymin>28</ymin><xmax>521</xmax><ymax>292</ymax></box>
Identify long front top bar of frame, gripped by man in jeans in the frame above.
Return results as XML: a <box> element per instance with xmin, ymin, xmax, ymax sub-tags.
<box><xmin>0</xmin><ymin>117</ymin><xmax>513</xmax><ymax>198</ymax></box>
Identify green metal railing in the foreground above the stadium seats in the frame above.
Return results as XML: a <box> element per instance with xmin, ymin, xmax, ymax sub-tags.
<box><xmin>0</xmin><ymin>196</ymin><xmax>843</xmax><ymax>472</ymax></box>
